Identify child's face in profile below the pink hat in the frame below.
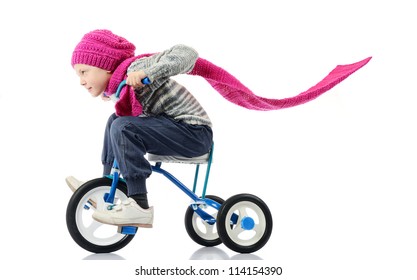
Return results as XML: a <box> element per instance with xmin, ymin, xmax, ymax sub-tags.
<box><xmin>74</xmin><ymin>64</ymin><xmax>111</xmax><ymax>97</ymax></box>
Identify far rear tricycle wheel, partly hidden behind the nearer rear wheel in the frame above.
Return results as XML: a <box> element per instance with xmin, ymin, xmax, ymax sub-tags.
<box><xmin>184</xmin><ymin>195</ymin><xmax>224</xmax><ymax>247</ymax></box>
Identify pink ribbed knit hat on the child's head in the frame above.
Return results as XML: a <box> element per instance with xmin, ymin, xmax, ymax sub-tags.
<box><xmin>71</xmin><ymin>29</ymin><xmax>136</xmax><ymax>72</ymax></box>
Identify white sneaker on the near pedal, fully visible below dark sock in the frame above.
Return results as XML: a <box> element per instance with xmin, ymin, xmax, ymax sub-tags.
<box><xmin>93</xmin><ymin>197</ymin><xmax>153</xmax><ymax>228</ymax></box>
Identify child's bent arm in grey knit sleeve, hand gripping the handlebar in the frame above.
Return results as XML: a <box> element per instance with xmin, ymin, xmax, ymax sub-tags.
<box><xmin>127</xmin><ymin>45</ymin><xmax>198</xmax><ymax>86</ymax></box>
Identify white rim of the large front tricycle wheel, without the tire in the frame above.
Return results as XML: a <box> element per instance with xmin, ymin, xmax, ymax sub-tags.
<box><xmin>75</xmin><ymin>186</ymin><xmax>127</xmax><ymax>246</ymax></box>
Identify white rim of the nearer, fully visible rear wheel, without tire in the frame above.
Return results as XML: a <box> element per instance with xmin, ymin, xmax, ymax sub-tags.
<box><xmin>225</xmin><ymin>201</ymin><xmax>266</xmax><ymax>246</ymax></box>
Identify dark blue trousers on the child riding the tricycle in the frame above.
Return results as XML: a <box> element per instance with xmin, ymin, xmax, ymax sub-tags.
<box><xmin>102</xmin><ymin>114</ymin><xmax>213</xmax><ymax>196</ymax></box>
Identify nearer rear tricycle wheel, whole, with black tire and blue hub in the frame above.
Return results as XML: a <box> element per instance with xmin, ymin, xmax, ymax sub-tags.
<box><xmin>217</xmin><ymin>194</ymin><xmax>272</xmax><ymax>253</ymax></box>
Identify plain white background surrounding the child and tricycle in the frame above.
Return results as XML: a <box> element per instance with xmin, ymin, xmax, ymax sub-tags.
<box><xmin>0</xmin><ymin>0</ymin><xmax>417</xmax><ymax>279</ymax></box>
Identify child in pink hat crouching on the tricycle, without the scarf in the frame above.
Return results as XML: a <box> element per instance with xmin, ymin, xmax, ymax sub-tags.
<box><xmin>66</xmin><ymin>30</ymin><xmax>213</xmax><ymax>227</ymax></box>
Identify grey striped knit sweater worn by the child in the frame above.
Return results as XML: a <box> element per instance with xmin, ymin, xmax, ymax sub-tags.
<box><xmin>127</xmin><ymin>45</ymin><xmax>212</xmax><ymax>127</ymax></box>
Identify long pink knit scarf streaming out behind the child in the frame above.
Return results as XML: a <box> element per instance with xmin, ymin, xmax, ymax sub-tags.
<box><xmin>106</xmin><ymin>54</ymin><xmax>372</xmax><ymax>116</ymax></box>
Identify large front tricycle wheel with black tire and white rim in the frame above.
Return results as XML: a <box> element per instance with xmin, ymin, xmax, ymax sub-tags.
<box><xmin>66</xmin><ymin>177</ymin><xmax>134</xmax><ymax>253</ymax></box>
